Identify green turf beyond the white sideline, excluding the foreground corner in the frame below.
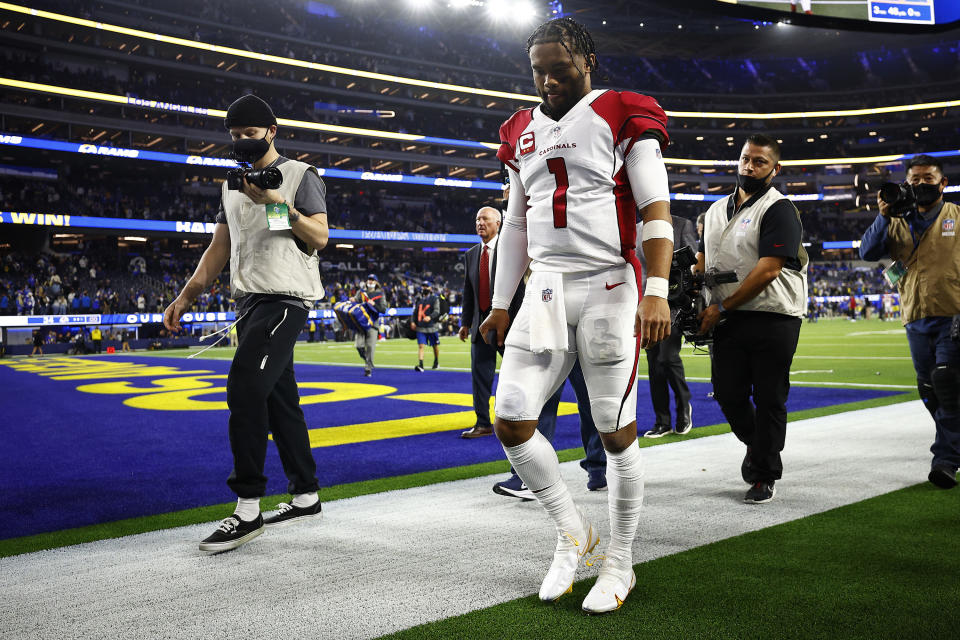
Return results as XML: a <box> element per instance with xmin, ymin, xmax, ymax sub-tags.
<box><xmin>0</xmin><ymin>320</ymin><xmax>917</xmax><ymax>557</ymax></box>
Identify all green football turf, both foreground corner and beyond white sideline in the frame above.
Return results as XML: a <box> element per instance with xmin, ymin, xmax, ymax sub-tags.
<box><xmin>0</xmin><ymin>319</ymin><xmax>960</xmax><ymax>639</ymax></box>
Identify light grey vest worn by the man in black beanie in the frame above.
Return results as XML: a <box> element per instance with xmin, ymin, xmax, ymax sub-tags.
<box><xmin>221</xmin><ymin>160</ymin><xmax>324</xmax><ymax>300</ymax></box>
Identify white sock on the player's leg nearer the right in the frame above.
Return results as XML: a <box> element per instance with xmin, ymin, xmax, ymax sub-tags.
<box><xmin>606</xmin><ymin>440</ymin><xmax>643</xmax><ymax>564</ymax></box>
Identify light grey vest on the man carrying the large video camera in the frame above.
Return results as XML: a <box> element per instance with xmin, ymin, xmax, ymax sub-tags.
<box><xmin>703</xmin><ymin>187</ymin><xmax>810</xmax><ymax>317</ymax></box>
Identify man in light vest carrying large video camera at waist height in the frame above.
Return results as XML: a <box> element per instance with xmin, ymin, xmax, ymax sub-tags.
<box><xmin>696</xmin><ymin>134</ymin><xmax>809</xmax><ymax>504</ymax></box>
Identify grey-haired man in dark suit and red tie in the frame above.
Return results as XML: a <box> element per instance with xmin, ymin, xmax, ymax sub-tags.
<box><xmin>459</xmin><ymin>207</ymin><xmax>524</xmax><ymax>438</ymax></box>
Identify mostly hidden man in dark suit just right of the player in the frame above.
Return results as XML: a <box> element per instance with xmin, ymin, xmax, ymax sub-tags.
<box><xmin>637</xmin><ymin>216</ymin><xmax>698</xmax><ymax>438</ymax></box>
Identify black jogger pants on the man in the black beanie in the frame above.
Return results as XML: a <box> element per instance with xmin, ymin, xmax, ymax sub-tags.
<box><xmin>227</xmin><ymin>301</ymin><xmax>318</xmax><ymax>498</ymax></box>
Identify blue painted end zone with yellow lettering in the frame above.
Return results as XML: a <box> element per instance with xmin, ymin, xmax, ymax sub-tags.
<box><xmin>0</xmin><ymin>356</ymin><xmax>897</xmax><ymax>539</ymax></box>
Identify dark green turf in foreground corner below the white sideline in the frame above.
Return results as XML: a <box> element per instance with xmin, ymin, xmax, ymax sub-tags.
<box><xmin>378</xmin><ymin>484</ymin><xmax>960</xmax><ymax>640</ymax></box>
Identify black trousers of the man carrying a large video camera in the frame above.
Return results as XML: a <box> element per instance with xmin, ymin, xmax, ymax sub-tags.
<box><xmin>713</xmin><ymin>311</ymin><xmax>801</xmax><ymax>481</ymax></box>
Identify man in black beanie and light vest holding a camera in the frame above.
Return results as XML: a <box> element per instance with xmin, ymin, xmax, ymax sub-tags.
<box><xmin>163</xmin><ymin>95</ymin><xmax>328</xmax><ymax>552</ymax></box>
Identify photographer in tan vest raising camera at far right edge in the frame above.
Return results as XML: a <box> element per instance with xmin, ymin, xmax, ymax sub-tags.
<box><xmin>860</xmin><ymin>155</ymin><xmax>960</xmax><ymax>489</ymax></box>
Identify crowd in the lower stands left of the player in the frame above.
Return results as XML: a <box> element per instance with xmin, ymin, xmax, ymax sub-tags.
<box><xmin>0</xmin><ymin>240</ymin><xmax>462</xmax><ymax>322</ymax></box>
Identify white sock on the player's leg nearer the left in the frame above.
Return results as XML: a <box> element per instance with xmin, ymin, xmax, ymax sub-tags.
<box><xmin>503</xmin><ymin>431</ymin><xmax>586</xmax><ymax>538</ymax></box>
